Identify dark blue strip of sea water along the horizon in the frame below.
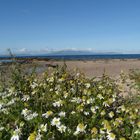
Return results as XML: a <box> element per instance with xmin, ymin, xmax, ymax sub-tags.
<box><xmin>0</xmin><ymin>54</ymin><xmax>140</xmax><ymax>62</ymax></box>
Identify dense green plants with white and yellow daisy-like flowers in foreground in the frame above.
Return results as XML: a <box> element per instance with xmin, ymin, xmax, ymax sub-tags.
<box><xmin>0</xmin><ymin>65</ymin><xmax>140</xmax><ymax>140</ymax></box>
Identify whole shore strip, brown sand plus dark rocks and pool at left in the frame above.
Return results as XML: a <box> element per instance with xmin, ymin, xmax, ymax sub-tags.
<box><xmin>0</xmin><ymin>59</ymin><xmax>140</xmax><ymax>78</ymax></box>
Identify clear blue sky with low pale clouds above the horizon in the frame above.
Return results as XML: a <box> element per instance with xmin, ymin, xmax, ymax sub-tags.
<box><xmin>0</xmin><ymin>0</ymin><xmax>140</xmax><ymax>53</ymax></box>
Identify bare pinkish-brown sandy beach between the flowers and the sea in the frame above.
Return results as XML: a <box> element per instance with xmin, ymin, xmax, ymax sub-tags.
<box><xmin>36</xmin><ymin>59</ymin><xmax>140</xmax><ymax>77</ymax></box>
